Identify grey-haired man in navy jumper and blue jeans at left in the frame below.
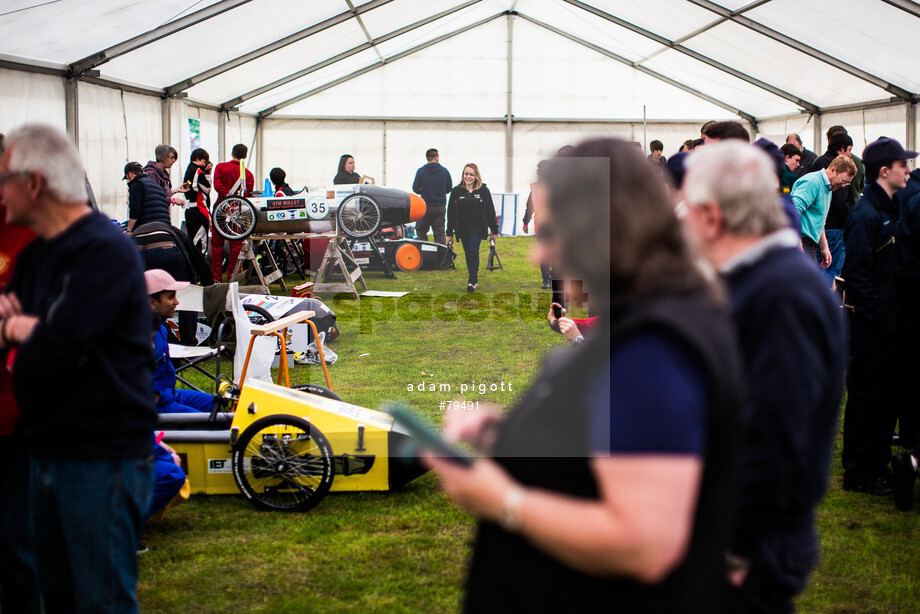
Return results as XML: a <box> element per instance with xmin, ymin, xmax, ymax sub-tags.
<box><xmin>0</xmin><ymin>125</ymin><xmax>156</xmax><ymax>612</ymax></box>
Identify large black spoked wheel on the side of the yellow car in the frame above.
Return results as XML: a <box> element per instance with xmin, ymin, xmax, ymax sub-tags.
<box><xmin>233</xmin><ymin>414</ymin><xmax>334</xmax><ymax>512</ymax></box>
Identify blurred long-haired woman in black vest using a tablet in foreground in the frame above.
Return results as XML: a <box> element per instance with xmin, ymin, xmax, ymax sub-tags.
<box><xmin>424</xmin><ymin>139</ymin><xmax>740</xmax><ymax>612</ymax></box>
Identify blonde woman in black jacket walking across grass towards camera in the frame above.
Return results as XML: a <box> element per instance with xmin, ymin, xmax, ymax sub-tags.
<box><xmin>446</xmin><ymin>162</ymin><xmax>498</xmax><ymax>292</ymax></box>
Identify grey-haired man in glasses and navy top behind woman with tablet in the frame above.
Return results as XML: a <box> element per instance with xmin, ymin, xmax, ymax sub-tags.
<box><xmin>684</xmin><ymin>141</ymin><xmax>845</xmax><ymax>612</ymax></box>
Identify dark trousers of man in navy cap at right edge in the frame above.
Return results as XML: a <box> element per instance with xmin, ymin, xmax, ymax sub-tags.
<box><xmin>842</xmin><ymin>314</ymin><xmax>900</xmax><ymax>483</ymax></box>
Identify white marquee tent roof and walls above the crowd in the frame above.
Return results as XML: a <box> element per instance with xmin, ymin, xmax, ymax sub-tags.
<box><xmin>0</xmin><ymin>0</ymin><xmax>920</xmax><ymax>219</ymax></box>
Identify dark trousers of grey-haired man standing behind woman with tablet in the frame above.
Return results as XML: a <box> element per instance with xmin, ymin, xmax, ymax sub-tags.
<box><xmin>725</xmin><ymin>528</ymin><xmax>819</xmax><ymax>614</ymax></box>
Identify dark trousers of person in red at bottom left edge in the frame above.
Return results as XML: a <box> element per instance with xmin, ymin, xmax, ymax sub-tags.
<box><xmin>0</xmin><ymin>435</ymin><xmax>41</xmax><ymax>614</ymax></box>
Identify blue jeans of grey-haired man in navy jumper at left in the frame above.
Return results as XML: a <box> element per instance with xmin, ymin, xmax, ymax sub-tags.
<box><xmin>29</xmin><ymin>458</ymin><xmax>153</xmax><ymax>614</ymax></box>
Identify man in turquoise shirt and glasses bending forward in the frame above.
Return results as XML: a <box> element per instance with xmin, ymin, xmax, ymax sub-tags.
<box><xmin>792</xmin><ymin>156</ymin><xmax>856</xmax><ymax>269</ymax></box>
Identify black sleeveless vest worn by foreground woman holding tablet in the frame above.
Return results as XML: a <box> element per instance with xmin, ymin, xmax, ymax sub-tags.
<box><xmin>465</xmin><ymin>295</ymin><xmax>741</xmax><ymax>614</ymax></box>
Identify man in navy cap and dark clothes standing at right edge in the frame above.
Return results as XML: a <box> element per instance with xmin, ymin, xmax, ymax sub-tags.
<box><xmin>842</xmin><ymin>137</ymin><xmax>917</xmax><ymax>495</ymax></box>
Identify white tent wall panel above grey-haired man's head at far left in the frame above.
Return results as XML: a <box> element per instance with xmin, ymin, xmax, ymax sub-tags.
<box><xmin>0</xmin><ymin>68</ymin><xmax>67</xmax><ymax>134</ymax></box>
